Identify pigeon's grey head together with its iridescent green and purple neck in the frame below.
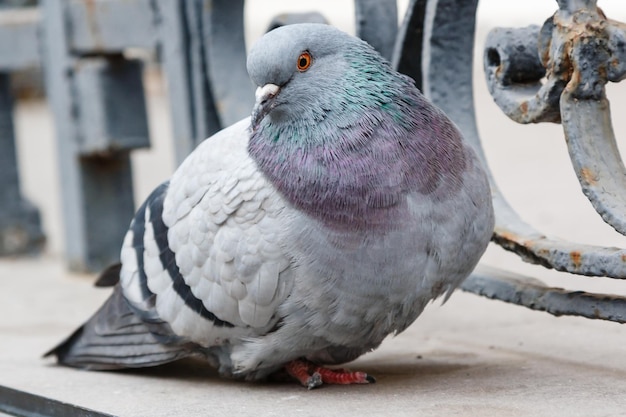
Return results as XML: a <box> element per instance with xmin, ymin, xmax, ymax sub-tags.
<box><xmin>247</xmin><ymin>24</ymin><xmax>464</xmax><ymax>228</ymax></box>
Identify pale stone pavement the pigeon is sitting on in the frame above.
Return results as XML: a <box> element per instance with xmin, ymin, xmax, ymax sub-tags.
<box><xmin>0</xmin><ymin>254</ymin><xmax>626</xmax><ymax>417</ymax></box>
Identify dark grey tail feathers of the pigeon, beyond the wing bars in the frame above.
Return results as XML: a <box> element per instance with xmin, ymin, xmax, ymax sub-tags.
<box><xmin>44</xmin><ymin>286</ymin><xmax>192</xmax><ymax>370</ymax></box>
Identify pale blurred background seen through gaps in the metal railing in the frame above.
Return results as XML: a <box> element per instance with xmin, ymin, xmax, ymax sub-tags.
<box><xmin>4</xmin><ymin>0</ymin><xmax>626</xmax><ymax>293</ymax></box>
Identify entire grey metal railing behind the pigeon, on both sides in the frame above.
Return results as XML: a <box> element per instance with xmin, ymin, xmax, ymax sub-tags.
<box><xmin>0</xmin><ymin>0</ymin><xmax>626</xmax><ymax>322</ymax></box>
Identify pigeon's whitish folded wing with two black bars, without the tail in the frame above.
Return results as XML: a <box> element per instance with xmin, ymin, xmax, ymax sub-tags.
<box><xmin>121</xmin><ymin>119</ymin><xmax>291</xmax><ymax>347</ymax></box>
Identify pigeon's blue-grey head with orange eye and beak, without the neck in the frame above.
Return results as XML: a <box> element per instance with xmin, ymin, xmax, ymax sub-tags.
<box><xmin>247</xmin><ymin>24</ymin><xmax>378</xmax><ymax>129</ymax></box>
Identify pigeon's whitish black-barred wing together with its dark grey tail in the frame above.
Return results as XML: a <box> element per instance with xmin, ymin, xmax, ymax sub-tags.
<box><xmin>46</xmin><ymin>119</ymin><xmax>292</xmax><ymax>369</ymax></box>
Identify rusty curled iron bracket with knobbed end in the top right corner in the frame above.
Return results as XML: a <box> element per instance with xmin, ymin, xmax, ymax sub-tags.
<box><xmin>485</xmin><ymin>1</ymin><xmax>626</xmax><ymax>234</ymax></box>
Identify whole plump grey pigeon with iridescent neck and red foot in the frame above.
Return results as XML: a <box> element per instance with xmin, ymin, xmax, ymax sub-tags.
<box><xmin>48</xmin><ymin>23</ymin><xmax>494</xmax><ymax>388</ymax></box>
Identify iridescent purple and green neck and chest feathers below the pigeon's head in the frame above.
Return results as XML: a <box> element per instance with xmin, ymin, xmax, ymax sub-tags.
<box><xmin>248</xmin><ymin>97</ymin><xmax>465</xmax><ymax>230</ymax></box>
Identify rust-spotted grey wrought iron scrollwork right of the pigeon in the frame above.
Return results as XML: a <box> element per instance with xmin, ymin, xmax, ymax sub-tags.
<box><xmin>393</xmin><ymin>0</ymin><xmax>626</xmax><ymax>322</ymax></box>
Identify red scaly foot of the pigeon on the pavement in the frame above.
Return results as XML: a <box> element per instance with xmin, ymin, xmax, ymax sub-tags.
<box><xmin>285</xmin><ymin>359</ymin><xmax>376</xmax><ymax>389</ymax></box>
